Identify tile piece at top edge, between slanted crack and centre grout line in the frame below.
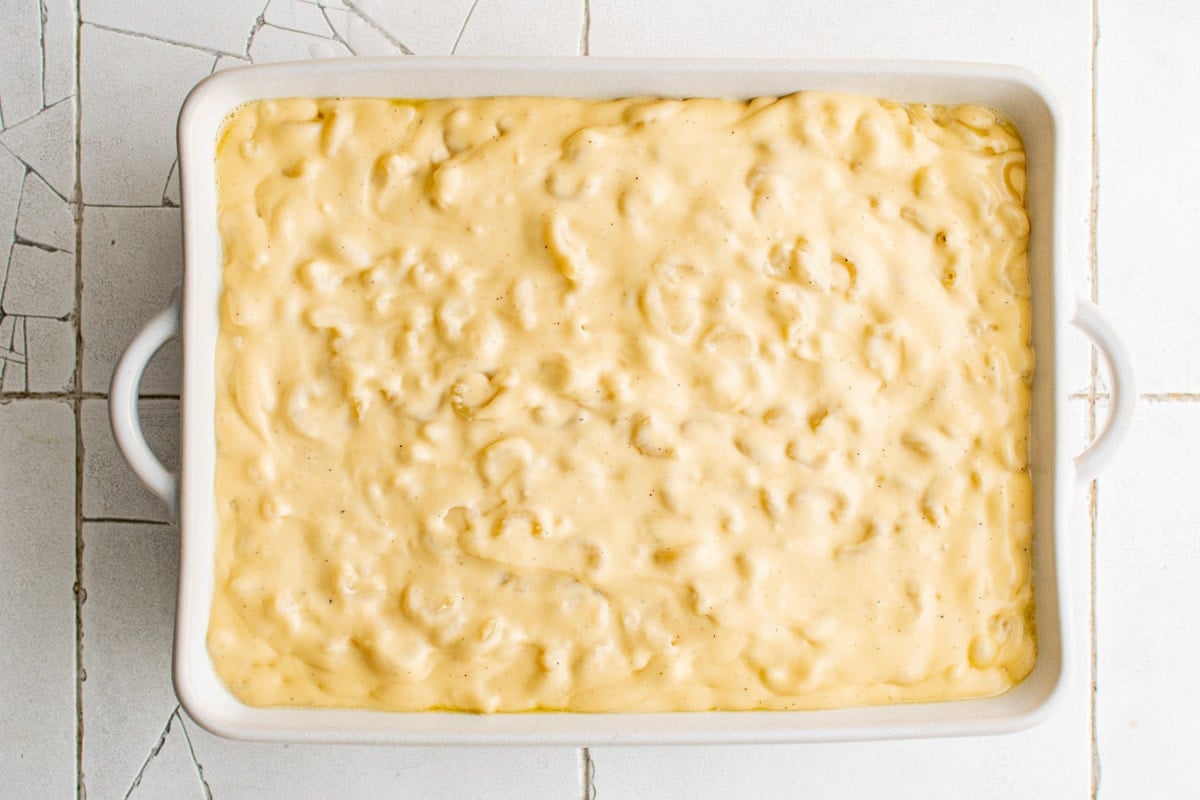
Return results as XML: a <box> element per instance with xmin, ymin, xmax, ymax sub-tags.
<box><xmin>455</xmin><ymin>0</ymin><xmax>583</xmax><ymax>55</ymax></box>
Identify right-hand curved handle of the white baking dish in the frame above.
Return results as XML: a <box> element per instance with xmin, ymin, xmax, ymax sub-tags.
<box><xmin>1070</xmin><ymin>297</ymin><xmax>1138</xmax><ymax>486</ymax></box>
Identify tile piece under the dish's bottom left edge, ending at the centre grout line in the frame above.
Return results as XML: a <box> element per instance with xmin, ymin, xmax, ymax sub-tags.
<box><xmin>180</xmin><ymin>711</ymin><xmax>583</xmax><ymax>800</ymax></box>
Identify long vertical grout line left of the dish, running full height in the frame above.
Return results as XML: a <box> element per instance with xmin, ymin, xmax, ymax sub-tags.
<box><xmin>73</xmin><ymin>0</ymin><xmax>88</xmax><ymax>800</ymax></box>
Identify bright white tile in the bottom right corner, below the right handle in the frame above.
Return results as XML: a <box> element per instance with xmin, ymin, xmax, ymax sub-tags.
<box><xmin>1096</xmin><ymin>402</ymin><xmax>1200</xmax><ymax>800</ymax></box>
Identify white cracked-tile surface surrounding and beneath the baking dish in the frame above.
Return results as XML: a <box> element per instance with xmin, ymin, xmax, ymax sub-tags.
<box><xmin>0</xmin><ymin>0</ymin><xmax>1200</xmax><ymax>800</ymax></box>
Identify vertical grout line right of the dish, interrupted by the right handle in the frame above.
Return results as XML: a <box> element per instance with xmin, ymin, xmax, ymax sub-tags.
<box><xmin>1087</xmin><ymin>0</ymin><xmax>1100</xmax><ymax>800</ymax></box>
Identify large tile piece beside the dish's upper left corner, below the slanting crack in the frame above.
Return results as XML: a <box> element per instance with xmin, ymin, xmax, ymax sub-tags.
<box><xmin>79</xmin><ymin>25</ymin><xmax>216</xmax><ymax>205</ymax></box>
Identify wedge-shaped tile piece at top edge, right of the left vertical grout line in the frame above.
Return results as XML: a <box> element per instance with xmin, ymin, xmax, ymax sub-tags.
<box><xmin>80</xmin><ymin>0</ymin><xmax>266</xmax><ymax>56</ymax></box>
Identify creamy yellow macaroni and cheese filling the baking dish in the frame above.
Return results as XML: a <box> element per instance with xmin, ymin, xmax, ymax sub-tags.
<box><xmin>208</xmin><ymin>92</ymin><xmax>1034</xmax><ymax>711</ymax></box>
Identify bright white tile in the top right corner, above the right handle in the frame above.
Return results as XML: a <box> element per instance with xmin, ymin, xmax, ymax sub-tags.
<box><xmin>1097</xmin><ymin>0</ymin><xmax>1200</xmax><ymax>392</ymax></box>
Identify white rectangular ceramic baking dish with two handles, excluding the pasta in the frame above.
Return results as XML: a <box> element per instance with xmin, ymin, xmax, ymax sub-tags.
<box><xmin>110</xmin><ymin>58</ymin><xmax>1135</xmax><ymax>745</ymax></box>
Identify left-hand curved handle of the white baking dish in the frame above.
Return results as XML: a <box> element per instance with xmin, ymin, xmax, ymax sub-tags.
<box><xmin>108</xmin><ymin>299</ymin><xmax>179</xmax><ymax>518</ymax></box>
